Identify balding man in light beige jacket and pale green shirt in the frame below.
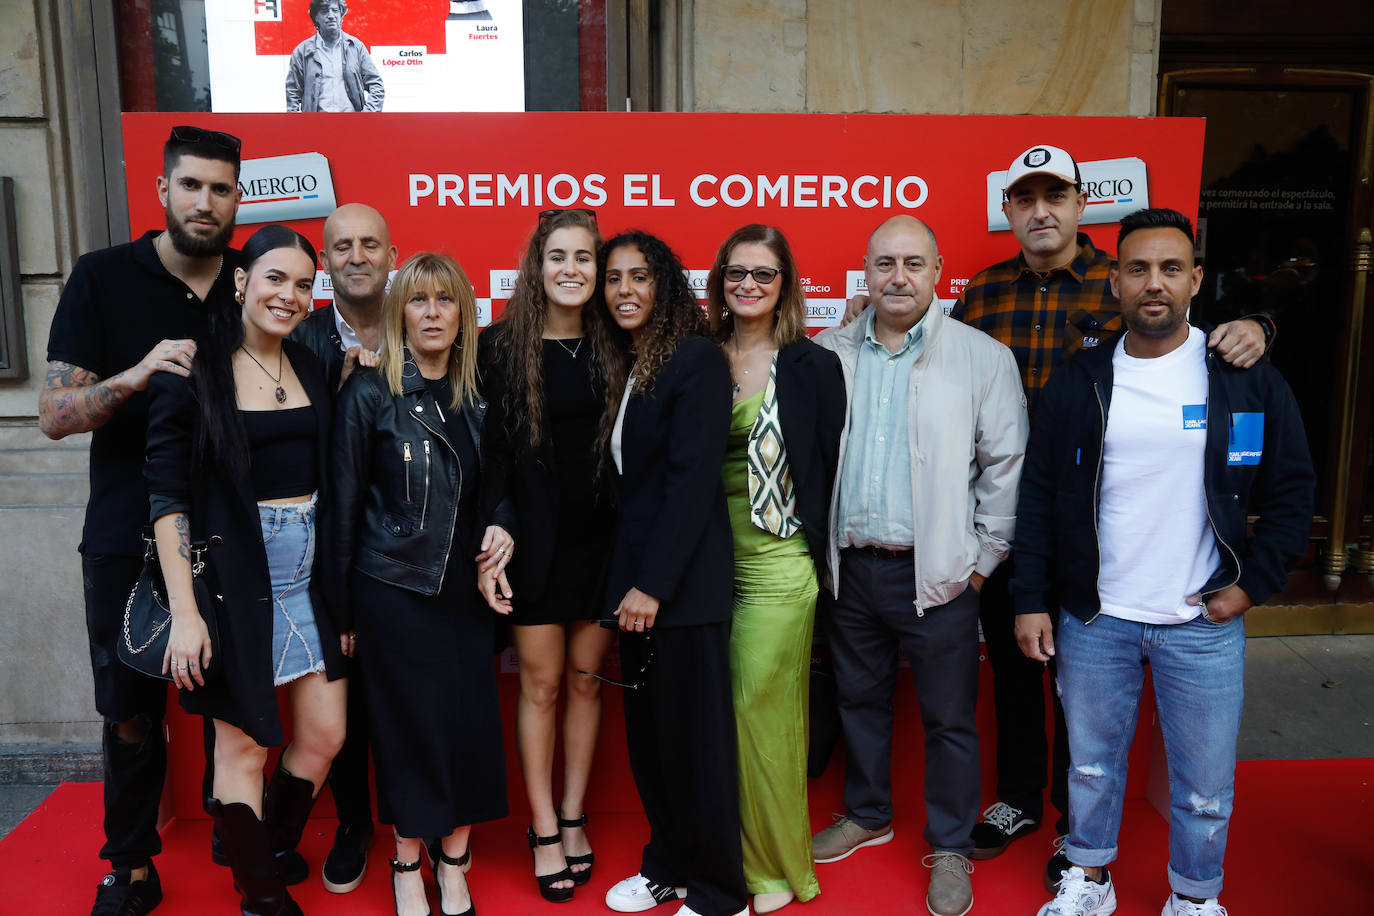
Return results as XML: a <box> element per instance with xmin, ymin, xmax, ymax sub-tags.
<box><xmin>813</xmin><ymin>214</ymin><xmax>1028</xmax><ymax>916</ymax></box>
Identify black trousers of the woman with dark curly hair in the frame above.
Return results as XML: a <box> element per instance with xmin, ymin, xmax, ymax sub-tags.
<box><xmin>620</xmin><ymin>622</ymin><xmax>749</xmax><ymax>916</ymax></box>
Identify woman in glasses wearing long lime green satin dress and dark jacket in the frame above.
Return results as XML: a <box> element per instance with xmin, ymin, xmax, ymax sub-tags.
<box><xmin>706</xmin><ymin>224</ymin><xmax>845</xmax><ymax>915</ymax></box>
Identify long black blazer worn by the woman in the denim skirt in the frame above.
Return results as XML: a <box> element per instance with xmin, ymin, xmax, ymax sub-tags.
<box><xmin>144</xmin><ymin>341</ymin><xmax>345</xmax><ymax>747</ymax></box>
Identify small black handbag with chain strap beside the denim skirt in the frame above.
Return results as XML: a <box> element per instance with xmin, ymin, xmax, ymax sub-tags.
<box><xmin>117</xmin><ymin>531</ymin><xmax>224</xmax><ymax>681</ymax></box>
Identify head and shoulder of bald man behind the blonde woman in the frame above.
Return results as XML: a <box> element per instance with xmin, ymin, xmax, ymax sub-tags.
<box><xmin>291</xmin><ymin>203</ymin><xmax>396</xmax><ymax>390</ymax></box>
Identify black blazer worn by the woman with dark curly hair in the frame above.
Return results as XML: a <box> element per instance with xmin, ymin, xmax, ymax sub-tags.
<box><xmin>603</xmin><ymin>336</ymin><xmax>735</xmax><ymax>626</ymax></box>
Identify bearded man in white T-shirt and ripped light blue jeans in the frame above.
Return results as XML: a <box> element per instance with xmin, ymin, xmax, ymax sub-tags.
<box><xmin>1011</xmin><ymin>209</ymin><xmax>1315</xmax><ymax>916</ymax></box>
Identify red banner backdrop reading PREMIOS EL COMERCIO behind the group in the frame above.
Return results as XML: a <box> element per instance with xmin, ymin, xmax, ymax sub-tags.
<box><xmin>124</xmin><ymin>113</ymin><xmax>1204</xmax><ymax>328</ymax></box>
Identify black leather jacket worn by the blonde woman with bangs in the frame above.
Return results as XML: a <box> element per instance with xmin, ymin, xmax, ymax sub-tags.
<box><xmin>322</xmin><ymin>352</ymin><xmax>515</xmax><ymax>628</ymax></box>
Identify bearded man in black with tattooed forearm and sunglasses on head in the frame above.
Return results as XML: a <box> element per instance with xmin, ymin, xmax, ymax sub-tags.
<box><xmin>38</xmin><ymin>126</ymin><xmax>240</xmax><ymax>916</ymax></box>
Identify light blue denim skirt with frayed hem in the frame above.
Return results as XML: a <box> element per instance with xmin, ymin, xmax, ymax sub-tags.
<box><xmin>258</xmin><ymin>496</ymin><xmax>324</xmax><ymax>685</ymax></box>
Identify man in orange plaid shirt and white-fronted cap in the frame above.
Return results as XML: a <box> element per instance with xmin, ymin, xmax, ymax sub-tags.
<box><xmin>952</xmin><ymin>144</ymin><xmax>1274</xmax><ymax>890</ymax></box>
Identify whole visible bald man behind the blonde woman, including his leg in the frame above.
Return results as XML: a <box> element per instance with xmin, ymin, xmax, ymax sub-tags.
<box><xmin>291</xmin><ymin>203</ymin><xmax>396</xmax><ymax>894</ymax></box>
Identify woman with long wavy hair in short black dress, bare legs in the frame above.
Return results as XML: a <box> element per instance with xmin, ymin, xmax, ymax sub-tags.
<box><xmin>478</xmin><ymin>210</ymin><xmax>611</xmax><ymax>902</ymax></box>
